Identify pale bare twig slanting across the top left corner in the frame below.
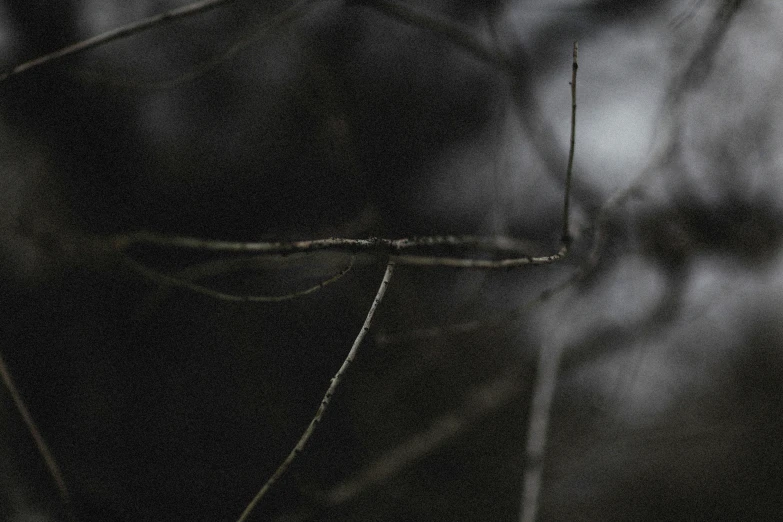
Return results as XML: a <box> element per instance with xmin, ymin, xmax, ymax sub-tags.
<box><xmin>0</xmin><ymin>0</ymin><xmax>233</xmax><ymax>82</ymax></box>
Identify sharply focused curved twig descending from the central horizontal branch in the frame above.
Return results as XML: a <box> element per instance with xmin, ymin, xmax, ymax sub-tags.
<box><xmin>237</xmin><ymin>261</ymin><xmax>394</xmax><ymax>522</ymax></box>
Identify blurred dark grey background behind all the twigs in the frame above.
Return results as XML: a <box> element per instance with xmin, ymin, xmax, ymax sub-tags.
<box><xmin>0</xmin><ymin>0</ymin><xmax>783</xmax><ymax>522</ymax></box>
